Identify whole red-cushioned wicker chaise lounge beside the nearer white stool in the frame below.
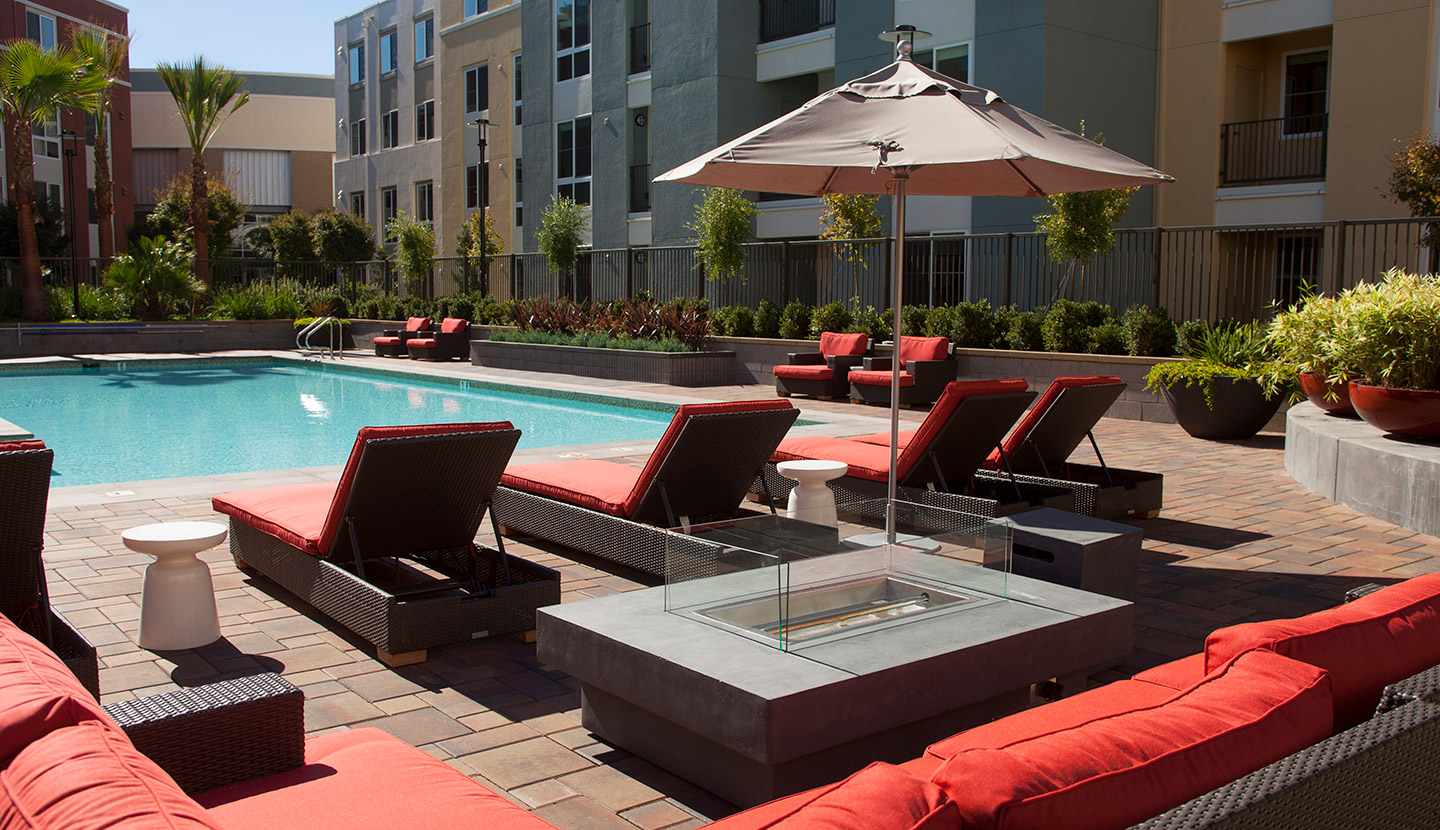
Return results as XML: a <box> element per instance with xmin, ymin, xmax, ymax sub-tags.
<box><xmin>212</xmin><ymin>421</ymin><xmax>560</xmax><ymax>666</ymax></box>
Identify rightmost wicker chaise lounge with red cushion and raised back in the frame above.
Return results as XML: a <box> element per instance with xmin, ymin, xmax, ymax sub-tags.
<box><xmin>854</xmin><ymin>375</ymin><xmax>1165</xmax><ymax>519</ymax></box>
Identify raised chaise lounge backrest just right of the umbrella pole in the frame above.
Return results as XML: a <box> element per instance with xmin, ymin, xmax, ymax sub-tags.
<box><xmin>896</xmin><ymin>380</ymin><xmax>1035</xmax><ymax>490</ymax></box>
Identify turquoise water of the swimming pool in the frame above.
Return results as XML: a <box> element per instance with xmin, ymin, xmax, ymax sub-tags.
<box><xmin>0</xmin><ymin>362</ymin><xmax>672</xmax><ymax>487</ymax></box>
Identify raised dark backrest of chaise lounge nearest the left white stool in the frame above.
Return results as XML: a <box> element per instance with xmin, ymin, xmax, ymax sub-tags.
<box><xmin>320</xmin><ymin>421</ymin><xmax>520</xmax><ymax>561</ymax></box>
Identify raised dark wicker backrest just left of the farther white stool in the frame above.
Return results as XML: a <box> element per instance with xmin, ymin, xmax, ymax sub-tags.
<box><xmin>629</xmin><ymin>401</ymin><xmax>799</xmax><ymax>527</ymax></box>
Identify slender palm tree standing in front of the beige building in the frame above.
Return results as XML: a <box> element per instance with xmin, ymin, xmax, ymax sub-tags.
<box><xmin>156</xmin><ymin>55</ymin><xmax>251</xmax><ymax>291</ymax></box>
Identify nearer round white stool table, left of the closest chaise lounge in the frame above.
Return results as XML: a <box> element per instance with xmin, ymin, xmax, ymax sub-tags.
<box><xmin>120</xmin><ymin>522</ymin><xmax>226</xmax><ymax>651</ymax></box>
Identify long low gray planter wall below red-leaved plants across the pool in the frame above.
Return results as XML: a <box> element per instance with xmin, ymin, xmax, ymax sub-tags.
<box><xmin>469</xmin><ymin>340</ymin><xmax>736</xmax><ymax>386</ymax></box>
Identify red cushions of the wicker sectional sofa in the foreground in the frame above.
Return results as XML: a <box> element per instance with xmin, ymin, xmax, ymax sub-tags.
<box><xmin>11</xmin><ymin>575</ymin><xmax>1440</xmax><ymax>830</ymax></box>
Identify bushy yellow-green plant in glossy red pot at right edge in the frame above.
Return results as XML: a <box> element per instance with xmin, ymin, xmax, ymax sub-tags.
<box><xmin>1333</xmin><ymin>269</ymin><xmax>1440</xmax><ymax>438</ymax></box>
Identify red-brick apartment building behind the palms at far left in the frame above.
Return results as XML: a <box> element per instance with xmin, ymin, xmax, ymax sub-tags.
<box><xmin>0</xmin><ymin>0</ymin><xmax>134</xmax><ymax>259</ymax></box>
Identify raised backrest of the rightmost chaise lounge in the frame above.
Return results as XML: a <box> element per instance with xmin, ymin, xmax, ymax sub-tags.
<box><xmin>986</xmin><ymin>375</ymin><xmax>1125</xmax><ymax>474</ymax></box>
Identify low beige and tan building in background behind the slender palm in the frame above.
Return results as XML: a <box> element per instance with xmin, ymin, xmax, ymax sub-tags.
<box><xmin>131</xmin><ymin>69</ymin><xmax>336</xmax><ymax>249</ymax></box>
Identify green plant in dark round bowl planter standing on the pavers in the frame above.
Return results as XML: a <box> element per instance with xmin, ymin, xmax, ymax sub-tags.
<box><xmin>1145</xmin><ymin>323</ymin><xmax>1295</xmax><ymax>439</ymax></box>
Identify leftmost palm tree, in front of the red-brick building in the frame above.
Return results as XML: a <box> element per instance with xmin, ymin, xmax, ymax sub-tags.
<box><xmin>0</xmin><ymin>39</ymin><xmax>105</xmax><ymax>320</ymax></box>
